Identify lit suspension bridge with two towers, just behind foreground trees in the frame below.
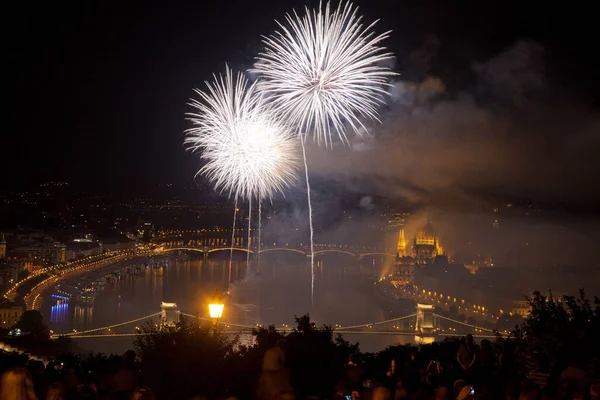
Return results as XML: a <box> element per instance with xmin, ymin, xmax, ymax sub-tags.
<box><xmin>52</xmin><ymin>303</ymin><xmax>505</xmax><ymax>341</ymax></box>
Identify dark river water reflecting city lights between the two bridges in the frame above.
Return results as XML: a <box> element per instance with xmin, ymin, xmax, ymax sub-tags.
<box><xmin>42</xmin><ymin>252</ymin><xmax>414</xmax><ymax>353</ymax></box>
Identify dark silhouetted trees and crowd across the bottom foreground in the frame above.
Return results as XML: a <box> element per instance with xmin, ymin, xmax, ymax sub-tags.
<box><xmin>0</xmin><ymin>292</ymin><xmax>600</xmax><ymax>400</ymax></box>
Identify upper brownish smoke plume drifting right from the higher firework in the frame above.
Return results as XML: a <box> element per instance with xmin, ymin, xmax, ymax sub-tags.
<box><xmin>308</xmin><ymin>41</ymin><xmax>600</xmax><ymax>203</ymax></box>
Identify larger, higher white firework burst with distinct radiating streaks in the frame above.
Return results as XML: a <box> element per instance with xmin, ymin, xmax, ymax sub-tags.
<box><xmin>253</xmin><ymin>2</ymin><xmax>395</xmax><ymax>146</ymax></box>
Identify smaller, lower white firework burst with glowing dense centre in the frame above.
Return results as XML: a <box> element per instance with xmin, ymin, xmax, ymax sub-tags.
<box><xmin>185</xmin><ymin>67</ymin><xmax>298</xmax><ymax>201</ymax></box>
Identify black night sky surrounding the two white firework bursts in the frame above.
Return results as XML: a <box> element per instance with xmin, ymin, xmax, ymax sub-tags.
<box><xmin>5</xmin><ymin>0</ymin><xmax>600</xmax><ymax>203</ymax></box>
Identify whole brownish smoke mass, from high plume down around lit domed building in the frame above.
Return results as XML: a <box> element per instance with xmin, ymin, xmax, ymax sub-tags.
<box><xmin>258</xmin><ymin>41</ymin><xmax>600</xmax><ymax>276</ymax></box>
